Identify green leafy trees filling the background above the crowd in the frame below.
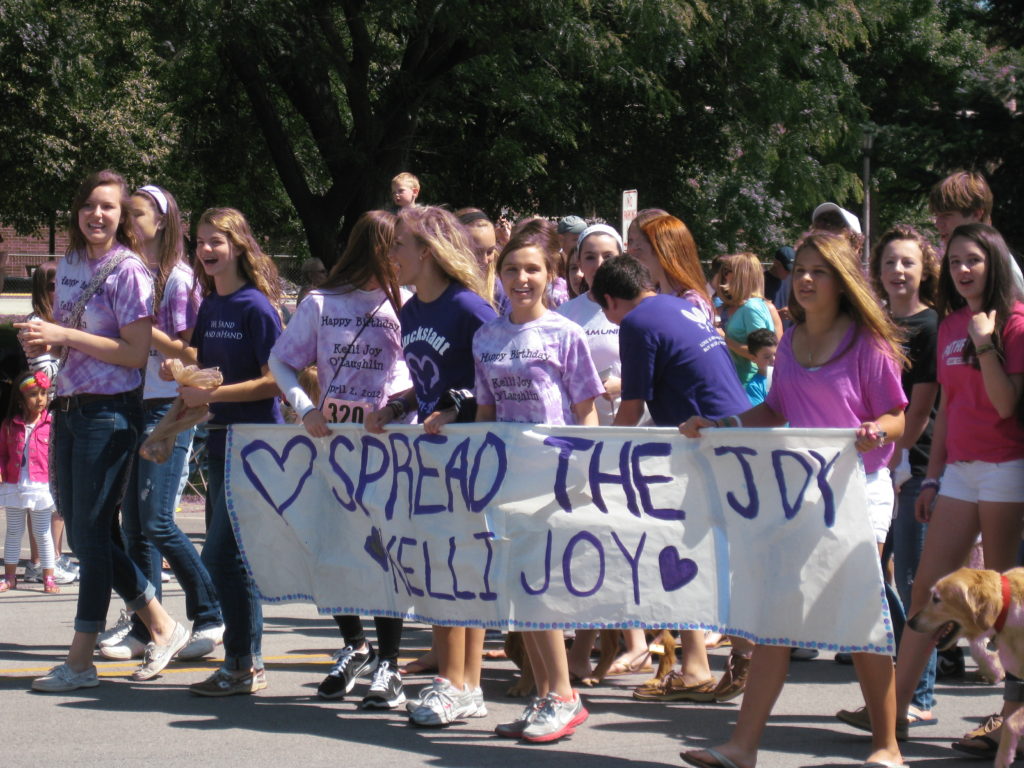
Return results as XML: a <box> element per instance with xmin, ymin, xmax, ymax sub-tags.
<box><xmin>0</xmin><ymin>0</ymin><xmax>1024</xmax><ymax>261</ymax></box>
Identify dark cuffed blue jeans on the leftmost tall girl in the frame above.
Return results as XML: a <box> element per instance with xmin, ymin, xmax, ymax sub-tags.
<box><xmin>50</xmin><ymin>395</ymin><xmax>156</xmax><ymax>633</ymax></box>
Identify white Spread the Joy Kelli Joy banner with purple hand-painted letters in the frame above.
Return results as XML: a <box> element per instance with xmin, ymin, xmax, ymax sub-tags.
<box><xmin>226</xmin><ymin>424</ymin><xmax>894</xmax><ymax>653</ymax></box>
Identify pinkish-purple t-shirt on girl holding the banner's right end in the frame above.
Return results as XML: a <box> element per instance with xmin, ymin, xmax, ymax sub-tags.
<box><xmin>765</xmin><ymin>324</ymin><xmax>907</xmax><ymax>474</ymax></box>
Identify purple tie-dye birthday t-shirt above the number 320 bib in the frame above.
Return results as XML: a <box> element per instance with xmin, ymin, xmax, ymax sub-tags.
<box><xmin>273</xmin><ymin>288</ymin><xmax>413</xmax><ymax>421</ymax></box>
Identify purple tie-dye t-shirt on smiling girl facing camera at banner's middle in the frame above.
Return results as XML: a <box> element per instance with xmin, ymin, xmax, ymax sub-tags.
<box><xmin>473</xmin><ymin>311</ymin><xmax>604</xmax><ymax>424</ymax></box>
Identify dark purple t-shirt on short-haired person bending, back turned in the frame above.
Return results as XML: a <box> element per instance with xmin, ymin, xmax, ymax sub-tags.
<box><xmin>618</xmin><ymin>295</ymin><xmax>750</xmax><ymax>427</ymax></box>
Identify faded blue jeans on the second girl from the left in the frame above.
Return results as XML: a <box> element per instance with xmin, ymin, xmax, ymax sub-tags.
<box><xmin>121</xmin><ymin>402</ymin><xmax>222</xmax><ymax>641</ymax></box>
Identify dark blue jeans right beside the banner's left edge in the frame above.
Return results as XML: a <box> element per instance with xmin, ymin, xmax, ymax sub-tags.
<box><xmin>203</xmin><ymin>456</ymin><xmax>263</xmax><ymax>672</ymax></box>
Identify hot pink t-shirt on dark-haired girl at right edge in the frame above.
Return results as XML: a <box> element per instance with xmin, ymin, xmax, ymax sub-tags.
<box><xmin>936</xmin><ymin>302</ymin><xmax>1024</xmax><ymax>463</ymax></box>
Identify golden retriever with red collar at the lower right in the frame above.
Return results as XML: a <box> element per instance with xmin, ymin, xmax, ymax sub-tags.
<box><xmin>907</xmin><ymin>568</ymin><xmax>1024</xmax><ymax>768</ymax></box>
